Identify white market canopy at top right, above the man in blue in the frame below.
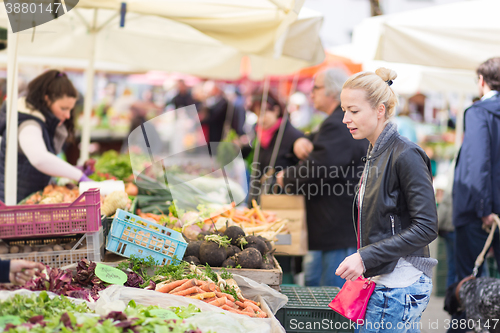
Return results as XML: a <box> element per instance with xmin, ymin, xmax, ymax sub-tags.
<box><xmin>353</xmin><ymin>0</ymin><xmax>500</xmax><ymax>71</ymax></box>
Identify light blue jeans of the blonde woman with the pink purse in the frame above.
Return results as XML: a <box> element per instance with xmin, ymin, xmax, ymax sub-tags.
<box><xmin>360</xmin><ymin>274</ymin><xmax>432</xmax><ymax>333</ymax></box>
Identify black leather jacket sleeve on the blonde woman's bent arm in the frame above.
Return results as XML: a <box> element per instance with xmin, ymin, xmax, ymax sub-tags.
<box><xmin>359</xmin><ymin>149</ymin><xmax>438</xmax><ymax>270</ymax></box>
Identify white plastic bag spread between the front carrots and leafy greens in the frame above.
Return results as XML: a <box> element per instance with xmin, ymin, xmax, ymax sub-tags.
<box><xmin>95</xmin><ymin>285</ymin><xmax>285</xmax><ymax>333</ymax></box>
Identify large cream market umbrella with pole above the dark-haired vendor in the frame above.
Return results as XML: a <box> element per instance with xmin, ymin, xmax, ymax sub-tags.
<box><xmin>0</xmin><ymin>0</ymin><xmax>322</xmax><ymax>202</ymax></box>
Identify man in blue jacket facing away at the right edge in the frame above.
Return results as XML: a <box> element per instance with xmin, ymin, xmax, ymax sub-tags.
<box><xmin>453</xmin><ymin>57</ymin><xmax>500</xmax><ymax>281</ymax></box>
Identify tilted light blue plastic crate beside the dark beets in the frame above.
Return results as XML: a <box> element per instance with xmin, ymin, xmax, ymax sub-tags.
<box><xmin>106</xmin><ymin>209</ymin><xmax>187</xmax><ymax>265</ymax></box>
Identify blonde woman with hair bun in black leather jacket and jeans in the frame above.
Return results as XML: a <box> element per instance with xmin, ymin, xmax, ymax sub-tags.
<box><xmin>336</xmin><ymin>68</ymin><xmax>438</xmax><ymax>332</ymax></box>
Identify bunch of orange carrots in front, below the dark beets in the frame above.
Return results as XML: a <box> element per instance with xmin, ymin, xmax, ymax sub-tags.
<box><xmin>156</xmin><ymin>279</ymin><xmax>267</xmax><ymax>318</ymax></box>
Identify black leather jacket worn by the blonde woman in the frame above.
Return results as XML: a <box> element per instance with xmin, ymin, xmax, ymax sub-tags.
<box><xmin>358</xmin><ymin>132</ymin><xmax>438</xmax><ymax>277</ymax></box>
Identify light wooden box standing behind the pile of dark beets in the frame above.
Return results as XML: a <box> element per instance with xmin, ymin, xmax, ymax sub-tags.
<box><xmin>260</xmin><ymin>194</ymin><xmax>308</xmax><ymax>256</ymax></box>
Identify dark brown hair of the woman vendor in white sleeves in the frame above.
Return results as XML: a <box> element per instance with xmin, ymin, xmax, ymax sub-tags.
<box><xmin>26</xmin><ymin>69</ymin><xmax>78</xmax><ymax>140</ymax></box>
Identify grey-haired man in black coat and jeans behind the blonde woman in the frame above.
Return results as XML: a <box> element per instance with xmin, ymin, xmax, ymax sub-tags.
<box><xmin>276</xmin><ymin>69</ymin><xmax>368</xmax><ymax>287</ymax></box>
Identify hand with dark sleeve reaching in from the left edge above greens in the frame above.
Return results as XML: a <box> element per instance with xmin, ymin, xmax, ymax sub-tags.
<box><xmin>0</xmin><ymin>260</ymin><xmax>45</xmax><ymax>285</ymax></box>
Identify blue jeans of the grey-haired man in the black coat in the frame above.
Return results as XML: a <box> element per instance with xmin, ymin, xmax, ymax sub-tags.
<box><xmin>304</xmin><ymin>247</ymin><xmax>356</xmax><ymax>288</ymax></box>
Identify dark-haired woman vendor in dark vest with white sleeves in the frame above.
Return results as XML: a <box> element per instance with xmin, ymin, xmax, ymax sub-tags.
<box><xmin>0</xmin><ymin>70</ymin><xmax>89</xmax><ymax>202</ymax></box>
